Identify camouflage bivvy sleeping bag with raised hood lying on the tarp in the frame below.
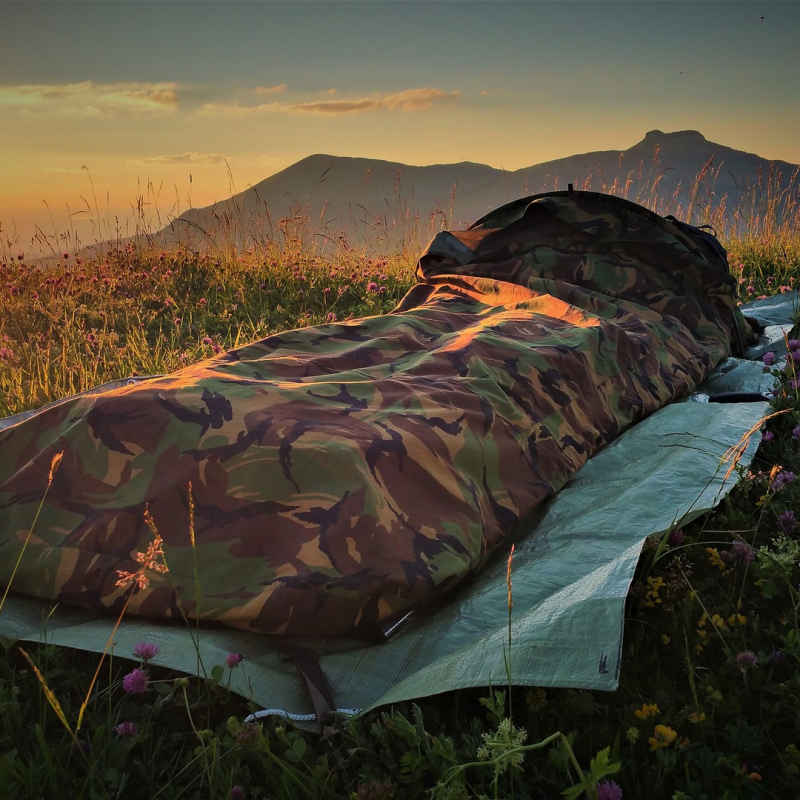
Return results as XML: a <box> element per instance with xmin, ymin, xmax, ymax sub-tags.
<box><xmin>0</xmin><ymin>191</ymin><xmax>744</xmax><ymax>637</ymax></box>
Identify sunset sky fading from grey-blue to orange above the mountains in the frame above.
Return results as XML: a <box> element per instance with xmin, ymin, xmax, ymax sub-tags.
<box><xmin>0</xmin><ymin>0</ymin><xmax>800</xmax><ymax>252</ymax></box>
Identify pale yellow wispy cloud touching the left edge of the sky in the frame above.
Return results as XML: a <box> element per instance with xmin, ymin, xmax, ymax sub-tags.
<box><xmin>0</xmin><ymin>81</ymin><xmax>180</xmax><ymax>112</ymax></box>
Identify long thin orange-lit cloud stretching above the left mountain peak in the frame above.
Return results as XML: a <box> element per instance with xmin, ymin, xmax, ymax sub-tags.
<box><xmin>199</xmin><ymin>87</ymin><xmax>460</xmax><ymax>117</ymax></box>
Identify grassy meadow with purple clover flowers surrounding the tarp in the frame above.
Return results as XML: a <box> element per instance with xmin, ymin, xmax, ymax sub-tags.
<box><xmin>0</xmin><ymin>175</ymin><xmax>800</xmax><ymax>800</ymax></box>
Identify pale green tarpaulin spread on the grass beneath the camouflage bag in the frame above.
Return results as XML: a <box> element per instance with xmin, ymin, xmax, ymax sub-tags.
<box><xmin>0</xmin><ymin>292</ymin><xmax>798</xmax><ymax>715</ymax></box>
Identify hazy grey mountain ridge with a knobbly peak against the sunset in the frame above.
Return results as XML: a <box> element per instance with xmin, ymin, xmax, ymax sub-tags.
<box><xmin>156</xmin><ymin>130</ymin><xmax>800</xmax><ymax>249</ymax></box>
